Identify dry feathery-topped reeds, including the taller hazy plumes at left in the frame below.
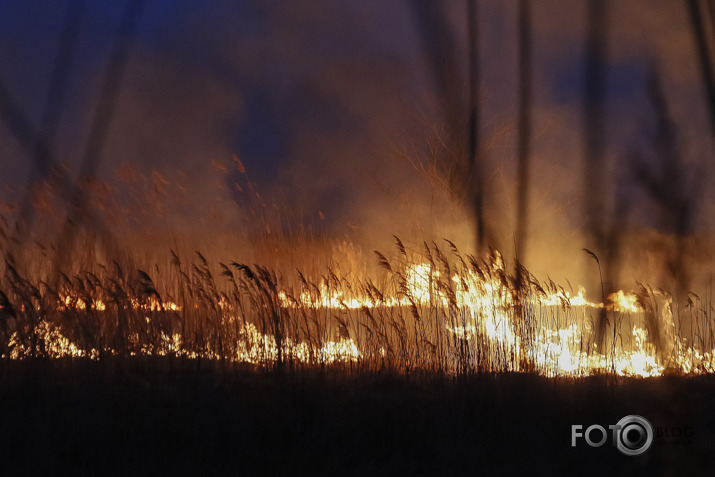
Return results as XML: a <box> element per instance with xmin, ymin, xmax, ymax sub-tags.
<box><xmin>0</xmin><ymin>167</ymin><xmax>715</xmax><ymax>375</ymax></box>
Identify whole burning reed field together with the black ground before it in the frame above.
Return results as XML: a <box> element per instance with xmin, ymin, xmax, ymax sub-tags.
<box><xmin>0</xmin><ymin>228</ymin><xmax>715</xmax><ymax>475</ymax></box>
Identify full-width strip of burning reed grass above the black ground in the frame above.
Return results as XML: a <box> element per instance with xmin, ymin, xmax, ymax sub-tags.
<box><xmin>0</xmin><ymin>237</ymin><xmax>715</xmax><ymax>377</ymax></box>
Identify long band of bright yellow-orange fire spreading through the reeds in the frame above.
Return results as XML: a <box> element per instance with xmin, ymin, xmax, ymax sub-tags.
<box><xmin>0</xmin><ymin>250</ymin><xmax>715</xmax><ymax>377</ymax></box>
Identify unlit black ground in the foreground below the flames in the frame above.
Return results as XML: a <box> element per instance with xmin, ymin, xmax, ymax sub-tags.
<box><xmin>0</xmin><ymin>358</ymin><xmax>715</xmax><ymax>476</ymax></box>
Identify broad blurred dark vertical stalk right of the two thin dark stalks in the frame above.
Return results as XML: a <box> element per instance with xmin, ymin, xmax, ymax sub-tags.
<box><xmin>582</xmin><ymin>0</ymin><xmax>609</xmax><ymax>351</ymax></box>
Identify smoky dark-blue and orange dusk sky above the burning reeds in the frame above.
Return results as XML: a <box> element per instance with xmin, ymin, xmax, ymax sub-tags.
<box><xmin>0</xmin><ymin>0</ymin><xmax>714</xmax><ymax>286</ymax></box>
